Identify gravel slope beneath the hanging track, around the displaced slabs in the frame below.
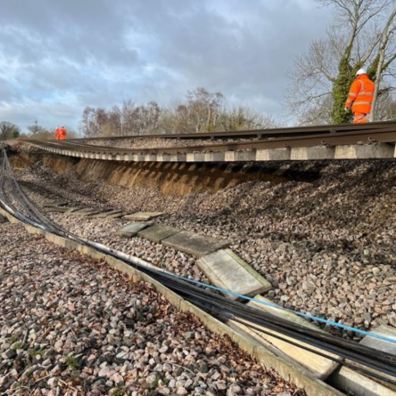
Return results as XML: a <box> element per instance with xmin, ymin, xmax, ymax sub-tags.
<box><xmin>14</xmin><ymin>160</ymin><xmax>396</xmax><ymax>329</ymax></box>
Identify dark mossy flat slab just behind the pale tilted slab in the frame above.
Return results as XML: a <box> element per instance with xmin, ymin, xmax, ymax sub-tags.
<box><xmin>162</xmin><ymin>231</ymin><xmax>230</xmax><ymax>257</ymax></box>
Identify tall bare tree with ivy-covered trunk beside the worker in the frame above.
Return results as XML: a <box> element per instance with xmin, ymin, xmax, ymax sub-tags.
<box><xmin>288</xmin><ymin>0</ymin><xmax>395</xmax><ymax>123</ymax></box>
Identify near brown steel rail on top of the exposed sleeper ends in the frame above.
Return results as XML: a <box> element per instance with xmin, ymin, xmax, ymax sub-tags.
<box><xmin>23</xmin><ymin>126</ymin><xmax>396</xmax><ymax>155</ymax></box>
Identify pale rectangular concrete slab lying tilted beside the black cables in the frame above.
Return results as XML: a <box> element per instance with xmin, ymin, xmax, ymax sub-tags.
<box><xmin>197</xmin><ymin>249</ymin><xmax>271</xmax><ymax>299</ymax></box>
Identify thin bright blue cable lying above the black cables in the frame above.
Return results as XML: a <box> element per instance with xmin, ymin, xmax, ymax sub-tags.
<box><xmin>166</xmin><ymin>271</ymin><xmax>396</xmax><ymax>344</ymax></box>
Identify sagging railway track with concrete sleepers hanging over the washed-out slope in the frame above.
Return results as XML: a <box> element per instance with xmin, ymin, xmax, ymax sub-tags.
<box><xmin>22</xmin><ymin>123</ymin><xmax>396</xmax><ymax>162</ymax></box>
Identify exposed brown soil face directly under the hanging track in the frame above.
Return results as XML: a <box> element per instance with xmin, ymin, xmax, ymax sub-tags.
<box><xmin>12</xmin><ymin>154</ymin><xmax>298</xmax><ymax>195</ymax></box>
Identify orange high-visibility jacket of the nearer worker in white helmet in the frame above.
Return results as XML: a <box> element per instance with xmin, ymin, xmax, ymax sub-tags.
<box><xmin>345</xmin><ymin>74</ymin><xmax>375</xmax><ymax>114</ymax></box>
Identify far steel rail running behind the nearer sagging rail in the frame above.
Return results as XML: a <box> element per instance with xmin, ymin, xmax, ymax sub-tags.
<box><xmin>68</xmin><ymin>120</ymin><xmax>396</xmax><ymax>142</ymax></box>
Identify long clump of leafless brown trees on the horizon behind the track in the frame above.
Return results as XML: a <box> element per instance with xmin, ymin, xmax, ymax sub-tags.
<box><xmin>81</xmin><ymin>88</ymin><xmax>274</xmax><ymax>136</ymax></box>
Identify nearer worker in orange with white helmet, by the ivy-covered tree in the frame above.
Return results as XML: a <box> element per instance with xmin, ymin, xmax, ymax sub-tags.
<box><xmin>345</xmin><ymin>69</ymin><xmax>375</xmax><ymax>124</ymax></box>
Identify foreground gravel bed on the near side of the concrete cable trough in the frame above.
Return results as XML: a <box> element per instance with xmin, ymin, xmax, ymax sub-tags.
<box><xmin>0</xmin><ymin>223</ymin><xmax>301</xmax><ymax>396</ymax></box>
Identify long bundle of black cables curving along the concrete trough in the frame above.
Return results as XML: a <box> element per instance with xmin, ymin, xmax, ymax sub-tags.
<box><xmin>0</xmin><ymin>148</ymin><xmax>396</xmax><ymax>392</ymax></box>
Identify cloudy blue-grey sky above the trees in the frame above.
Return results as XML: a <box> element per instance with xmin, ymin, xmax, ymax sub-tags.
<box><xmin>0</xmin><ymin>0</ymin><xmax>331</xmax><ymax>133</ymax></box>
